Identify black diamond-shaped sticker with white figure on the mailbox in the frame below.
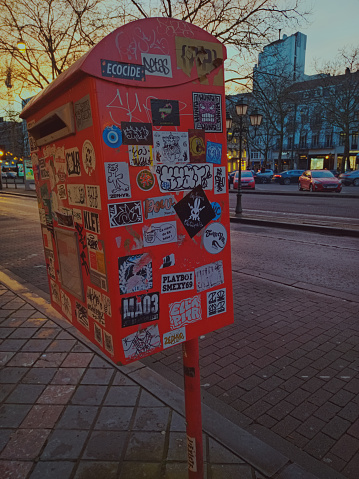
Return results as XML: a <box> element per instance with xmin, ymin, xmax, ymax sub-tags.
<box><xmin>174</xmin><ymin>185</ymin><xmax>216</xmax><ymax>238</ymax></box>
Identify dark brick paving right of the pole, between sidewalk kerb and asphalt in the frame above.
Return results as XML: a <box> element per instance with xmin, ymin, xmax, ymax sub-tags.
<box><xmin>145</xmin><ymin>273</ymin><xmax>359</xmax><ymax>479</ymax></box>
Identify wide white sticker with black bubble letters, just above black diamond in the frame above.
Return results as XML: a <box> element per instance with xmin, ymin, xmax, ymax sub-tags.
<box><xmin>156</xmin><ymin>163</ymin><xmax>213</xmax><ymax>193</ymax></box>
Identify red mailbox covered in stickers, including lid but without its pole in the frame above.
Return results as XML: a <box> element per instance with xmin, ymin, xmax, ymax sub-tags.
<box><xmin>21</xmin><ymin>18</ymin><xmax>233</xmax><ymax>363</ymax></box>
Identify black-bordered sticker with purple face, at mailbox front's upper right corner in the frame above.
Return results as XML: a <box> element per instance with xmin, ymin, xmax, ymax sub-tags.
<box><xmin>192</xmin><ymin>92</ymin><xmax>222</xmax><ymax>133</ymax></box>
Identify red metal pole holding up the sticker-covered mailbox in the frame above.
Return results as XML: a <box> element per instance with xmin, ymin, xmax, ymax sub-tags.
<box><xmin>182</xmin><ymin>338</ymin><xmax>203</xmax><ymax>479</ymax></box>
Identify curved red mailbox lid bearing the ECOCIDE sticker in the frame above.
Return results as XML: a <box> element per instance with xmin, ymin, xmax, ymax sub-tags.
<box><xmin>20</xmin><ymin>17</ymin><xmax>227</xmax><ymax>119</ymax></box>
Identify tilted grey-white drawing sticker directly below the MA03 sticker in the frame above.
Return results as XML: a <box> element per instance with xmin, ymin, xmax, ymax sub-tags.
<box><xmin>122</xmin><ymin>324</ymin><xmax>161</xmax><ymax>360</ymax></box>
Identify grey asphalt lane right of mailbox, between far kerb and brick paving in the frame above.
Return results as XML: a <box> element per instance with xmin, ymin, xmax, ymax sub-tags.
<box><xmin>231</xmin><ymin>224</ymin><xmax>359</xmax><ymax>294</ymax></box>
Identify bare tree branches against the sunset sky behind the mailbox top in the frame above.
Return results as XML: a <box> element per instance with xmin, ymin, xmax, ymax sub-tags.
<box><xmin>0</xmin><ymin>0</ymin><xmax>305</xmax><ymax>111</ymax></box>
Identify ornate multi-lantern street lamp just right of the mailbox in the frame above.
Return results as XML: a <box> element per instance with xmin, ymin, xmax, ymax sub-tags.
<box><xmin>226</xmin><ymin>98</ymin><xmax>263</xmax><ymax>215</ymax></box>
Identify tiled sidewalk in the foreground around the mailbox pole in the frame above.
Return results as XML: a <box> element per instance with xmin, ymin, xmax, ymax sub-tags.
<box><xmin>0</xmin><ymin>272</ymin><xmax>322</xmax><ymax>479</ymax></box>
